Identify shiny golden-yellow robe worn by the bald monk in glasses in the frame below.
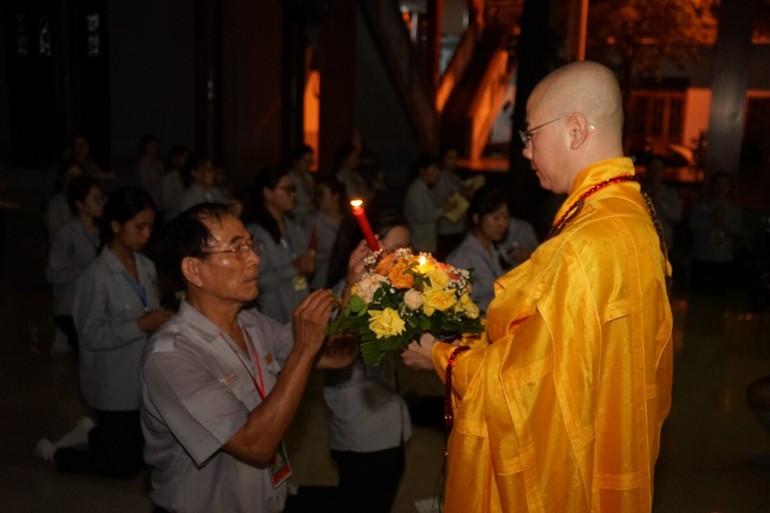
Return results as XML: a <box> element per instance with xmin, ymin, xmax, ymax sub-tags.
<box><xmin>433</xmin><ymin>158</ymin><xmax>672</xmax><ymax>513</ymax></box>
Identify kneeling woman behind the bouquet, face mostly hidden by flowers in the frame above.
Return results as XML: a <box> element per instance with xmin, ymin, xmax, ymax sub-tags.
<box><xmin>324</xmin><ymin>210</ymin><xmax>412</xmax><ymax>513</ymax></box>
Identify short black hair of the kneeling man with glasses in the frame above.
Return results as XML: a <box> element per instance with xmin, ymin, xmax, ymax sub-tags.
<box><xmin>157</xmin><ymin>203</ymin><xmax>233</xmax><ymax>284</ymax></box>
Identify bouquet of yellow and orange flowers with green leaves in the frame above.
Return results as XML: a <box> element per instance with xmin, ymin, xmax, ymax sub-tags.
<box><xmin>327</xmin><ymin>249</ymin><xmax>482</xmax><ymax>365</ymax></box>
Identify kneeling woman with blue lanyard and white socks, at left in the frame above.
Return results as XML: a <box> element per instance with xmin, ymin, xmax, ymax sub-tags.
<box><xmin>54</xmin><ymin>187</ymin><xmax>171</xmax><ymax>478</ymax></box>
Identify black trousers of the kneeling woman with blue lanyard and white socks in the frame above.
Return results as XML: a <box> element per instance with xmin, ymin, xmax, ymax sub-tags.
<box><xmin>54</xmin><ymin>410</ymin><xmax>144</xmax><ymax>479</ymax></box>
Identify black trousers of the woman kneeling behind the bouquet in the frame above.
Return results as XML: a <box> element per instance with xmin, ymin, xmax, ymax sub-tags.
<box><xmin>332</xmin><ymin>444</ymin><xmax>405</xmax><ymax>513</ymax></box>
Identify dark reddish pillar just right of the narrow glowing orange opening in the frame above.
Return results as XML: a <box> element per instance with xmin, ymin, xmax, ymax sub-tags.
<box><xmin>318</xmin><ymin>0</ymin><xmax>356</xmax><ymax>173</ymax></box>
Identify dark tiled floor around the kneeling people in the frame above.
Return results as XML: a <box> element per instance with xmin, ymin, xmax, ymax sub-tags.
<box><xmin>0</xmin><ymin>170</ymin><xmax>770</xmax><ymax>513</ymax></box>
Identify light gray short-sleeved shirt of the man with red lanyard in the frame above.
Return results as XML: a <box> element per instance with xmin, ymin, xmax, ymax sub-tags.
<box><xmin>141</xmin><ymin>301</ymin><xmax>294</xmax><ymax>513</ymax></box>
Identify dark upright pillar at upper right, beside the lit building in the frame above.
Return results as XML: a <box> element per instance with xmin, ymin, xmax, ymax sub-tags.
<box><xmin>706</xmin><ymin>0</ymin><xmax>757</xmax><ymax>177</ymax></box>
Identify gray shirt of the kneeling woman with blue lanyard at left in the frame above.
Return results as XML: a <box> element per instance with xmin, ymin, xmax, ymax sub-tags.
<box><xmin>72</xmin><ymin>248</ymin><xmax>160</xmax><ymax>411</ymax></box>
